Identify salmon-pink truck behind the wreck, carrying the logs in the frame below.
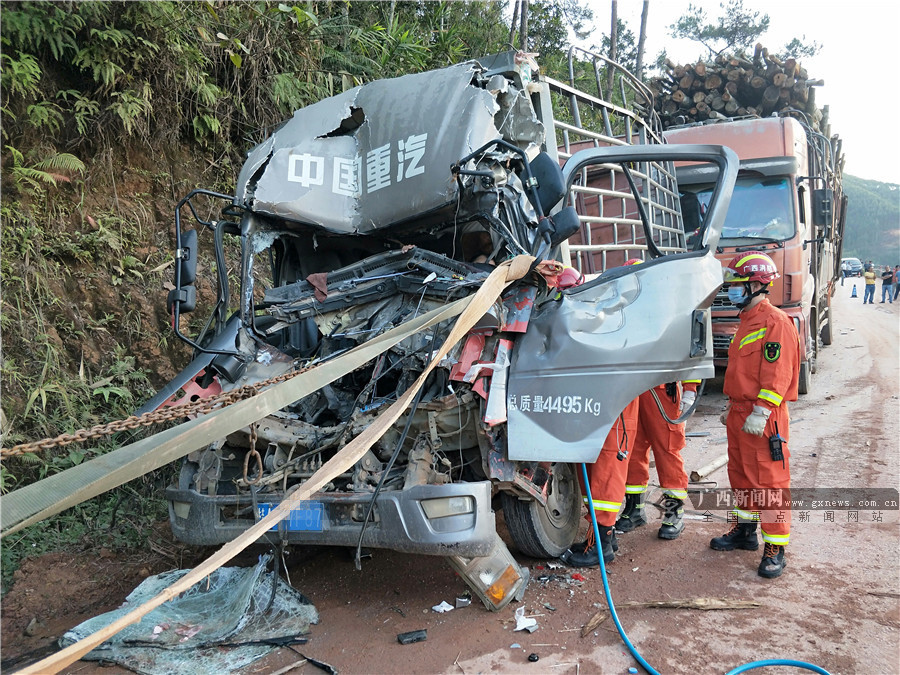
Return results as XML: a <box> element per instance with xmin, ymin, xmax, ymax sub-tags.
<box><xmin>663</xmin><ymin>110</ymin><xmax>847</xmax><ymax>394</ymax></box>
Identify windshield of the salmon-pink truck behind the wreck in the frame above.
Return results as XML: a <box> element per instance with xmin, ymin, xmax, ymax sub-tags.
<box><xmin>681</xmin><ymin>177</ymin><xmax>796</xmax><ymax>246</ymax></box>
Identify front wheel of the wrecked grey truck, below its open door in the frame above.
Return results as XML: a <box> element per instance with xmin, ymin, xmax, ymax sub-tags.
<box><xmin>501</xmin><ymin>463</ymin><xmax>581</xmax><ymax>558</ymax></box>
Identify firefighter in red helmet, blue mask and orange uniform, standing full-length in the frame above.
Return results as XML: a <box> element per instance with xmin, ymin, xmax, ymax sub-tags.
<box><xmin>709</xmin><ymin>251</ymin><xmax>800</xmax><ymax>579</ymax></box>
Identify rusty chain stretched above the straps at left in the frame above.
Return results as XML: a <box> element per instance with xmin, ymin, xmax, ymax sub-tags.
<box><xmin>0</xmin><ymin>367</ymin><xmax>309</xmax><ymax>458</ymax></box>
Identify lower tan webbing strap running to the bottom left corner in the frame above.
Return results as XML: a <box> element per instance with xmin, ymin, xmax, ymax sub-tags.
<box><xmin>21</xmin><ymin>255</ymin><xmax>534</xmax><ymax>674</ymax></box>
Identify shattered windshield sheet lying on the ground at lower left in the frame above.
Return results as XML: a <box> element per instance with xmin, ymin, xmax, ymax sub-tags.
<box><xmin>59</xmin><ymin>556</ymin><xmax>316</xmax><ymax>675</ymax></box>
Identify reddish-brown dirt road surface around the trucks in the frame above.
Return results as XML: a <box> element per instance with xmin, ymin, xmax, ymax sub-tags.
<box><xmin>2</xmin><ymin>288</ymin><xmax>900</xmax><ymax>675</ymax></box>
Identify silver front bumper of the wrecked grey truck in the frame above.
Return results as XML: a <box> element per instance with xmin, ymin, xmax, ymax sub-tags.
<box><xmin>166</xmin><ymin>481</ymin><xmax>496</xmax><ymax>557</ymax></box>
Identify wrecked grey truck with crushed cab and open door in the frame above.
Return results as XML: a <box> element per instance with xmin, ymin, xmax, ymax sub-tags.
<box><xmin>142</xmin><ymin>53</ymin><xmax>735</xmax><ymax>608</ymax></box>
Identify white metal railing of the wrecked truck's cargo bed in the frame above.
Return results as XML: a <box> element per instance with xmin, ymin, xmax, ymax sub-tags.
<box><xmin>544</xmin><ymin>47</ymin><xmax>689</xmax><ymax>274</ymax></box>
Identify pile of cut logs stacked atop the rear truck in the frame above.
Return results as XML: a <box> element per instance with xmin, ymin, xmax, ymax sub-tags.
<box><xmin>650</xmin><ymin>44</ymin><xmax>830</xmax><ymax>135</ymax></box>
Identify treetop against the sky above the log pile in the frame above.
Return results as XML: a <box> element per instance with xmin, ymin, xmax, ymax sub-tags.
<box><xmin>669</xmin><ymin>0</ymin><xmax>769</xmax><ymax>56</ymax></box>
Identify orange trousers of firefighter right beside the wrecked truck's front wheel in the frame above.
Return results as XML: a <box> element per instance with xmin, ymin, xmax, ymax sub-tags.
<box><xmin>579</xmin><ymin>398</ymin><xmax>639</xmax><ymax>528</ymax></box>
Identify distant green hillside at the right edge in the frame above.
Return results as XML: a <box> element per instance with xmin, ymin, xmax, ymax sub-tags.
<box><xmin>843</xmin><ymin>176</ymin><xmax>900</xmax><ymax>265</ymax></box>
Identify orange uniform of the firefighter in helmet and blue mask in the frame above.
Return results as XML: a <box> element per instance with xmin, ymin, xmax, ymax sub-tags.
<box><xmin>723</xmin><ymin>299</ymin><xmax>800</xmax><ymax>546</ymax></box>
